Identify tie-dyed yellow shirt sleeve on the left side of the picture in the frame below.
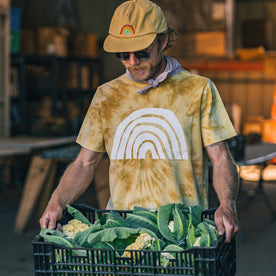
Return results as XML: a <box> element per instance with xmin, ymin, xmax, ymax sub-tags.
<box><xmin>76</xmin><ymin>88</ymin><xmax>106</xmax><ymax>152</ymax></box>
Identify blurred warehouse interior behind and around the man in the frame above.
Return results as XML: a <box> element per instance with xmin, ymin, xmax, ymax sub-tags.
<box><xmin>0</xmin><ymin>0</ymin><xmax>276</xmax><ymax>276</ymax></box>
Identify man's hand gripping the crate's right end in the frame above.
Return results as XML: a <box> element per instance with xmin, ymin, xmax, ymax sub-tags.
<box><xmin>215</xmin><ymin>206</ymin><xmax>239</xmax><ymax>242</ymax></box>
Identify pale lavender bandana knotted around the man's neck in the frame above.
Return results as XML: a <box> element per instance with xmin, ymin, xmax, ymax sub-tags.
<box><xmin>126</xmin><ymin>56</ymin><xmax>184</xmax><ymax>94</ymax></box>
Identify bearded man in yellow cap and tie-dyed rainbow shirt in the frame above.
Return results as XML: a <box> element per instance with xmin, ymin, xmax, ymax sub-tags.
<box><xmin>40</xmin><ymin>0</ymin><xmax>238</xmax><ymax>242</ymax></box>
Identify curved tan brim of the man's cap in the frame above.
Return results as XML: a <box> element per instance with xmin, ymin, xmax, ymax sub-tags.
<box><xmin>103</xmin><ymin>33</ymin><xmax>157</xmax><ymax>53</ymax></box>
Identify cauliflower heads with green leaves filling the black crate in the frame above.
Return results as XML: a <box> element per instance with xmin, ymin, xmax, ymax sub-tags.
<box><xmin>40</xmin><ymin>203</ymin><xmax>217</xmax><ymax>265</ymax></box>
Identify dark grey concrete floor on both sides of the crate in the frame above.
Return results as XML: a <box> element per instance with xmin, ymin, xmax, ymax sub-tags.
<box><xmin>0</xmin><ymin>179</ymin><xmax>276</xmax><ymax>276</ymax></box>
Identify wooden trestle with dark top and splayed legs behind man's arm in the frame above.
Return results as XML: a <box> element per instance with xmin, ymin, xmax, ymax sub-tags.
<box><xmin>15</xmin><ymin>144</ymin><xmax>109</xmax><ymax>233</ymax></box>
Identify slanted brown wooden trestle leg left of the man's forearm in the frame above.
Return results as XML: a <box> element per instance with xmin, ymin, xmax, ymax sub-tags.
<box><xmin>14</xmin><ymin>155</ymin><xmax>53</xmax><ymax>233</ymax></box>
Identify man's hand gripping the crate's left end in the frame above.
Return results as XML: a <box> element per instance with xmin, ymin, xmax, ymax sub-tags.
<box><xmin>39</xmin><ymin>203</ymin><xmax>63</xmax><ymax>230</ymax></box>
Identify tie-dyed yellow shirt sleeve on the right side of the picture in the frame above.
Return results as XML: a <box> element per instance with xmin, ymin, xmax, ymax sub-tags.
<box><xmin>201</xmin><ymin>80</ymin><xmax>236</xmax><ymax>147</ymax></box>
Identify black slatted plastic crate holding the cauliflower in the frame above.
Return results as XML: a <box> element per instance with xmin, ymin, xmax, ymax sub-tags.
<box><xmin>32</xmin><ymin>205</ymin><xmax>236</xmax><ymax>276</ymax></box>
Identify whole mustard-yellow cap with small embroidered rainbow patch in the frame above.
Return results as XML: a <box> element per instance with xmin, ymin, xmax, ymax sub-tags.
<box><xmin>103</xmin><ymin>0</ymin><xmax>168</xmax><ymax>53</ymax></box>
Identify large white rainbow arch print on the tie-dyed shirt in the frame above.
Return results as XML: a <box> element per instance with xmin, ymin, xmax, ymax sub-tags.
<box><xmin>110</xmin><ymin>108</ymin><xmax>188</xmax><ymax>160</ymax></box>
